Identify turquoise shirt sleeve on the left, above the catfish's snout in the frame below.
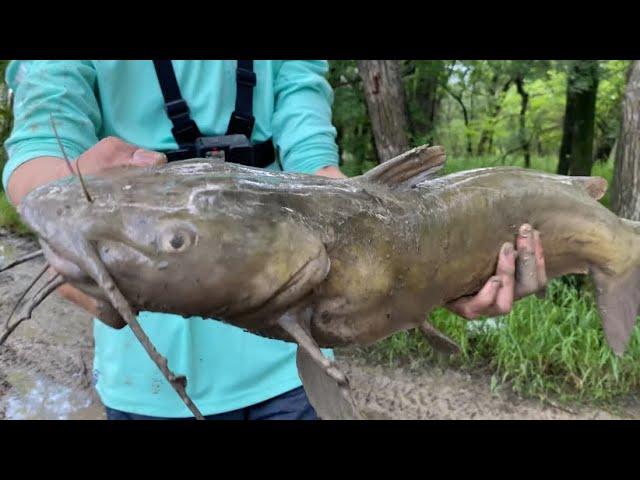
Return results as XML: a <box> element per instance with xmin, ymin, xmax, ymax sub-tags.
<box><xmin>2</xmin><ymin>60</ymin><xmax>102</xmax><ymax>190</ymax></box>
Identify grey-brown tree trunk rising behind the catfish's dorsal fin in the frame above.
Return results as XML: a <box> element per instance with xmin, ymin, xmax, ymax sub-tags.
<box><xmin>358</xmin><ymin>60</ymin><xmax>410</xmax><ymax>163</ymax></box>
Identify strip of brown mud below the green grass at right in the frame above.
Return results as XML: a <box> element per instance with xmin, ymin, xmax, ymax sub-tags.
<box><xmin>340</xmin><ymin>354</ymin><xmax>640</xmax><ymax>420</ymax></box>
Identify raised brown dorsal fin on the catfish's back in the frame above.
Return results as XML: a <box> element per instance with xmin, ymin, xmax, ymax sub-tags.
<box><xmin>361</xmin><ymin>145</ymin><xmax>446</xmax><ymax>188</ymax></box>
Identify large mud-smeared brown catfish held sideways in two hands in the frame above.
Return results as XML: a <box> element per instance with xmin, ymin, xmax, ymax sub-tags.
<box><xmin>8</xmin><ymin>147</ymin><xmax>640</xmax><ymax>418</ymax></box>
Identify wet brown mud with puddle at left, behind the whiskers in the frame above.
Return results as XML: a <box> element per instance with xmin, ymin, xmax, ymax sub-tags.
<box><xmin>0</xmin><ymin>230</ymin><xmax>104</xmax><ymax>419</ymax></box>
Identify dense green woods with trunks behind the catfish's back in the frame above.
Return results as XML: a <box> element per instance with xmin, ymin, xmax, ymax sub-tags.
<box><xmin>329</xmin><ymin>60</ymin><xmax>631</xmax><ymax>181</ymax></box>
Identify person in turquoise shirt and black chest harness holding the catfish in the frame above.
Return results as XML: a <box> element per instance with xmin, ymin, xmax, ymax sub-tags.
<box><xmin>3</xmin><ymin>60</ymin><xmax>546</xmax><ymax>419</ymax></box>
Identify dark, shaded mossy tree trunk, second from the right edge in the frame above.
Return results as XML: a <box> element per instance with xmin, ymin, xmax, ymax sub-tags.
<box><xmin>558</xmin><ymin>60</ymin><xmax>598</xmax><ymax>175</ymax></box>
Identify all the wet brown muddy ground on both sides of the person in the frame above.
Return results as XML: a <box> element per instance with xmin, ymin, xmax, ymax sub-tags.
<box><xmin>0</xmin><ymin>229</ymin><xmax>640</xmax><ymax>419</ymax></box>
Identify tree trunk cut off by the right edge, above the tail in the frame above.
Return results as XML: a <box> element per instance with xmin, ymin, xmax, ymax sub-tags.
<box><xmin>611</xmin><ymin>60</ymin><xmax>640</xmax><ymax>221</ymax></box>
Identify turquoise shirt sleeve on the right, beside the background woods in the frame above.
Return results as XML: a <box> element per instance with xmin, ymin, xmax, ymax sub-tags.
<box><xmin>272</xmin><ymin>60</ymin><xmax>339</xmax><ymax>173</ymax></box>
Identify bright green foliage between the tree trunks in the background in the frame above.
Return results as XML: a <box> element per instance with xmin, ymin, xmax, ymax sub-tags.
<box><xmin>330</xmin><ymin>60</ymin><xmax>629</xmax><ymax>171</ymax></box>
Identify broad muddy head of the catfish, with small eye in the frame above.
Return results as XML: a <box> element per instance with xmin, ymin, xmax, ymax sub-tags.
<box><xmin>19</xmin><ymin>169</ymin><xmax>329</xmax><ymax>324</ymax></box>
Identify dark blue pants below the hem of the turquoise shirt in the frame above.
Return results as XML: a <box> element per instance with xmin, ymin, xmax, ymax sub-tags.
<box><xmin>105</xmin><ymin>387</ymin><xmax>319</xmax><ymax>420</ymax></box>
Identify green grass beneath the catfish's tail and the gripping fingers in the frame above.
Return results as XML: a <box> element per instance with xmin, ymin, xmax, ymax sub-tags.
<box><xmin>363</xmin><ymin>280</ymin><xmax>640</xmax><ymax>403</ymax></box>
